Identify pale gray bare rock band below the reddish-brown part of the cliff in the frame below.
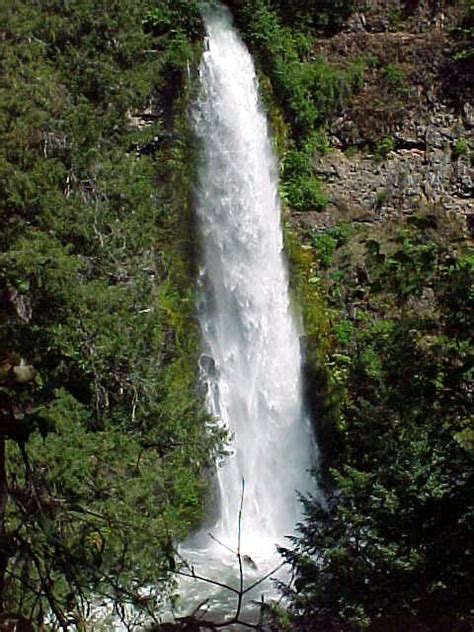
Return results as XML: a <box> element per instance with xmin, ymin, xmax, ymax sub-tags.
<box><xmin>314</xmin><ymin>111</ymin><xmax>474</xmax><ymax>226</ymax></box>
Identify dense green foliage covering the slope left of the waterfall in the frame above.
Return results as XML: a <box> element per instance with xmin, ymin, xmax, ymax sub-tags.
<box><xmin>0</xmin><ymin>0</ymin><xmax>222</xmax><ymax>627</ymax></box>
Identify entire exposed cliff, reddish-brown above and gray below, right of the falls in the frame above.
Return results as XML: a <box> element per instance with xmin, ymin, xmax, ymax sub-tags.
<box><xmin>296</xmin><ymin>0</ymin><xmax>474</xmax><ymax>235</ymax></box>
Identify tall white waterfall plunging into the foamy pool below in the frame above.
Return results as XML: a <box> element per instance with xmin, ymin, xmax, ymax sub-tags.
<box><xmin>182</xmin><ymin>6</ymin><xmax>315</xmax><ymax>613</ymax></box>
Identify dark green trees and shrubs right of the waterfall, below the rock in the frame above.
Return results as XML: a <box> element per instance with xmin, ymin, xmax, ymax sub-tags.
<box><xmin>287</xmin><ymin>214</ymin><xmax>474</xmax><ymax>629</ymax></box>
